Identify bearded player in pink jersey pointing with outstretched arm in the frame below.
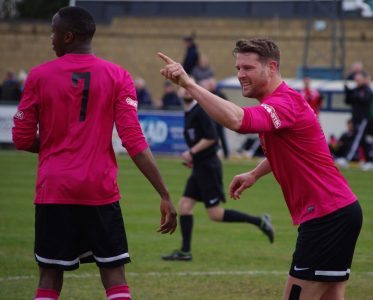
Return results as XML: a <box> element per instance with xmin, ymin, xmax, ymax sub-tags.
<box><xmin>159</xmin><ymin>39</ymin><xmax>362</xmax><ymax>300</ymax></box>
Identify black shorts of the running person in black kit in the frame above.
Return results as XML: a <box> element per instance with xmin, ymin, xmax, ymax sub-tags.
<box><xmin>183</xmin><ymin>156</ymin><xmax>225</xmax><ymax>208</ymax></box>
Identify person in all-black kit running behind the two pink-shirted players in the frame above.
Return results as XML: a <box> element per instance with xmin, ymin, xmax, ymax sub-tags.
<box><xmin>162</xmin><ymin>89</ymin><xmax>274</xmax><ymax>261</ymax></box>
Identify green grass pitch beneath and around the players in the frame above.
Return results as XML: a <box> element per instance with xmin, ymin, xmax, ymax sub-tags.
<box><xmin>0</xmin><ymin>151</ymin><xmax>373</xmax><ymax>300</ymax></box>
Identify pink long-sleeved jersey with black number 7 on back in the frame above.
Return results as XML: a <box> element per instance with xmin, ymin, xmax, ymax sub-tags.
<box><xmin>13</xmin><ymin>54</ymin><xmax>148</xmax><ymax>205</ymax></box>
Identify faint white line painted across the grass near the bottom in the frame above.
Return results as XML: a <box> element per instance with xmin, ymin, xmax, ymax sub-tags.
<box><xmin>0</xmin><ymin>270</ymin><xmax>373</xmax><ymax>282</ymax></box>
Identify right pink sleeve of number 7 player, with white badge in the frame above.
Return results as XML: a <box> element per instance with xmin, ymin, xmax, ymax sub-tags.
<box><xmin>115</xmin><ymin>71</ymin><xmax>148</xmax><ymax>157</ymax></box>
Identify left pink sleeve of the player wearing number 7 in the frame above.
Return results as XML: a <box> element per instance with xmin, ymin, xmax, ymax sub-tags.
<box><xmin>12</xmin><ymin>72</ymin><xmax>39</xmax><ymax>150</ymax></box>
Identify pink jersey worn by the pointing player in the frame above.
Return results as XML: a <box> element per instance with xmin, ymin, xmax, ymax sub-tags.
<box><xmin>240</xmin><ymin>82</ymin><xmax>357</xmax><ymax>224</ymax></box>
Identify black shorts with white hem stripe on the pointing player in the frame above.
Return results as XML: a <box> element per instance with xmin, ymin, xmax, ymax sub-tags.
<box><xmin>289</xmin><ymin>201</ymin><xmax>363</xmax><ymax>282</ymax></box>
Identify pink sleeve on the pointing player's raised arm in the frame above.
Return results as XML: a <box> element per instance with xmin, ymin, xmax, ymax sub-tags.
<box><xmin>239</xmin><ymin>96</ymin><xmax>296</xmax><ymax>133</ymax></box>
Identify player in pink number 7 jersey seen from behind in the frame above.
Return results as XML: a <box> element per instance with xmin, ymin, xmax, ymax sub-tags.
<box><xmin>13</xmin><ymin>7</ymin><xmax>176</xmax><ymax>300</ymax></box>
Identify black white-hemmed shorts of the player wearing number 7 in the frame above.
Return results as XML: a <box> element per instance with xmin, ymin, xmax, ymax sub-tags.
<box><xmin>35</xmin><ymin>202</ymin><xmax>130</xmax><ymax>270</ymax></box>
